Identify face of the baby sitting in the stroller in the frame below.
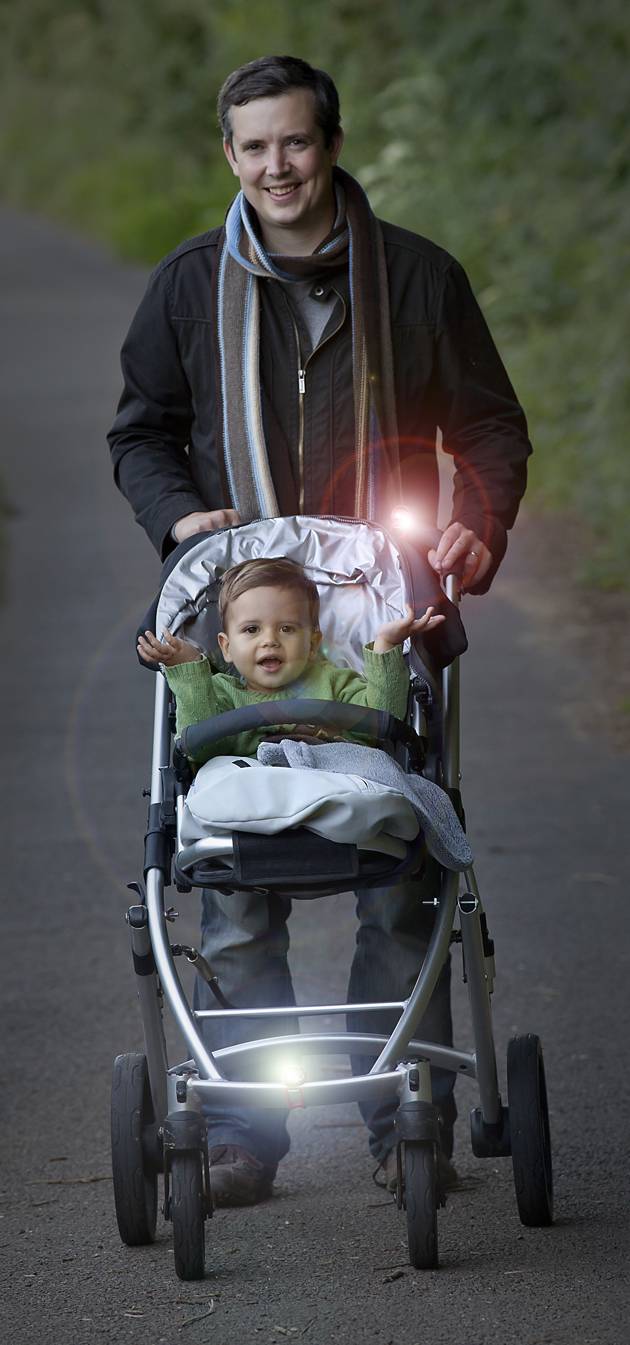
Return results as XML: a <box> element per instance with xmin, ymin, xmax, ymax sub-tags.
<box><xmin>219</xmin><ymin>588</ymin><xmax>322</xmax><ymax>691</ymax></box>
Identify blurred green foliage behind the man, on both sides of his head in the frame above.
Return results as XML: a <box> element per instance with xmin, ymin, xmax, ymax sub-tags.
<box><xmin>0</xmin><ymin>0</ymin><xmax>630</xmax><ymax>586</ymax></box>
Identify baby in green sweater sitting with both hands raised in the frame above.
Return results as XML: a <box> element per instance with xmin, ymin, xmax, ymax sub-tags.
<box><xmin>137</xmin><ymin>557</ymin><xmax>444</xmax><ymax>763</ymax></box>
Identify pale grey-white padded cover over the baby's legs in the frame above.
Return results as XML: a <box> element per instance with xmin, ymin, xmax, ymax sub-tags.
<box><xmin>182</xmin><ymin>756</ymin><xmax>420</xmax><ymax>858</ymax></box>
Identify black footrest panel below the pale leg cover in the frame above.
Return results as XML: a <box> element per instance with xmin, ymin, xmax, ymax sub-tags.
<box><xmin>233</xmin><ymin>827</ymin><xmax>359</xmax><ymax>886</ymax></box>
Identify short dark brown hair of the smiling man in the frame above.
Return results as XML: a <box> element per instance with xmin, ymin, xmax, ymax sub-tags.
<box><xmin>217</xmin><ymin>56</ymin><xmax>341</xmax><ymax>149</ymax></box>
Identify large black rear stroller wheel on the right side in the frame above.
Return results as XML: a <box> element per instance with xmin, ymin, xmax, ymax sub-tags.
<box><xmin>508</xmin><ymin>1033</ymin><xmax>553</xmax><ymax>1228</ymax></box>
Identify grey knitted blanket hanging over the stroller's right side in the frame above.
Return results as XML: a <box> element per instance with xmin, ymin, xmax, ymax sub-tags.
<box><xmin>257</xmin><ymin>738</ymin><xmax>473</xmax><ymax>870</ymax></box>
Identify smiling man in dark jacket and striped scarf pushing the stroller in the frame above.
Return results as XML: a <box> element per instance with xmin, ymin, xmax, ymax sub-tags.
<box><xmin>109</xmin><ymin>56</ymin><xmax>530</xmax><ymax>1204</ymax></box>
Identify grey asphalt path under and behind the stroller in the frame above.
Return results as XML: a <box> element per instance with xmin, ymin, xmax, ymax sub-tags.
<box><xmin>0</xmin><ymin>211</ymin><xmax>629</xmax><ymax>1345</ymax></box>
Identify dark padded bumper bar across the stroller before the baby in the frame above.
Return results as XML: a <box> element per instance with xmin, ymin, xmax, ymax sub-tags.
<box><xmin>178</xmin><ymin>699</ymin><xmax>424</xmax><ymax>761</ymax></box>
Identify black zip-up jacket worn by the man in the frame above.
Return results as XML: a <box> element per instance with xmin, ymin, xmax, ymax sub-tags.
<box><xmin>109</xmin><ymin>223</ymin><xmax>530</xmax><ymax>592</ymax></box>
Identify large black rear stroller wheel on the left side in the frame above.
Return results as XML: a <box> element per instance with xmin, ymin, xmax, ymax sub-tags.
<box><xmin>112</xmin><ymin>1052</ymin><xmax>158</xmax><ymax>1247</ymax></box>
